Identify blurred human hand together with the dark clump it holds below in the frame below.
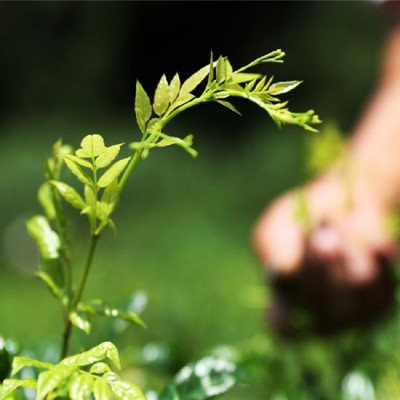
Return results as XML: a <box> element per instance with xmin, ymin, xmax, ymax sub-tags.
<box><xmin>254</xmin><ymin>173</ymin><xmax>397</xmax><ymax>334</ymax></box>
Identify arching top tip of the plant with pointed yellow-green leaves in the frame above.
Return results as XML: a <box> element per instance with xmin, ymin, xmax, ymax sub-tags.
<box><xmin>130</xmin><ymin>50</ymin><xmax>320</xmax><ymax>161</ymax></box>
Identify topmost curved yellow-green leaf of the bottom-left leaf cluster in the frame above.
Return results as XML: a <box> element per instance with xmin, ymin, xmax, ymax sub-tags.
<box><xmin>60</xmin><ymin>342</ymin><xmax>121</xmax><ymax>369</ymax></box>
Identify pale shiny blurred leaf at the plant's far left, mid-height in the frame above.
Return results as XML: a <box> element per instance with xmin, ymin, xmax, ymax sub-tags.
<box><xmin>27</xmin><ymin>215</ymin><xmax>61</xmax><ymax>260</ymax></box>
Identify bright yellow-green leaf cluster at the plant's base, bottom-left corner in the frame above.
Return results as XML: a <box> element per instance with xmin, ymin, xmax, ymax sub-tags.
<box><xmin>0</xmin><ymin>342</ymin><xmax>145</xmax><ymax>400</ymax></box>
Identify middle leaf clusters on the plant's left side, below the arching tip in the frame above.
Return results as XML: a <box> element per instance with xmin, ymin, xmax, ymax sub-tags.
<box><xmin>27</xmin><ymin>138</ymin><xmax>144</xmax><ymax>354</ymax></box>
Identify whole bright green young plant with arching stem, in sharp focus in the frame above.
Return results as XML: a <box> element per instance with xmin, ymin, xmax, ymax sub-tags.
<box><xmin>1</xmin><ymin>50</ymin><xmax>320</xmax><ymax>400</ymax></box>
